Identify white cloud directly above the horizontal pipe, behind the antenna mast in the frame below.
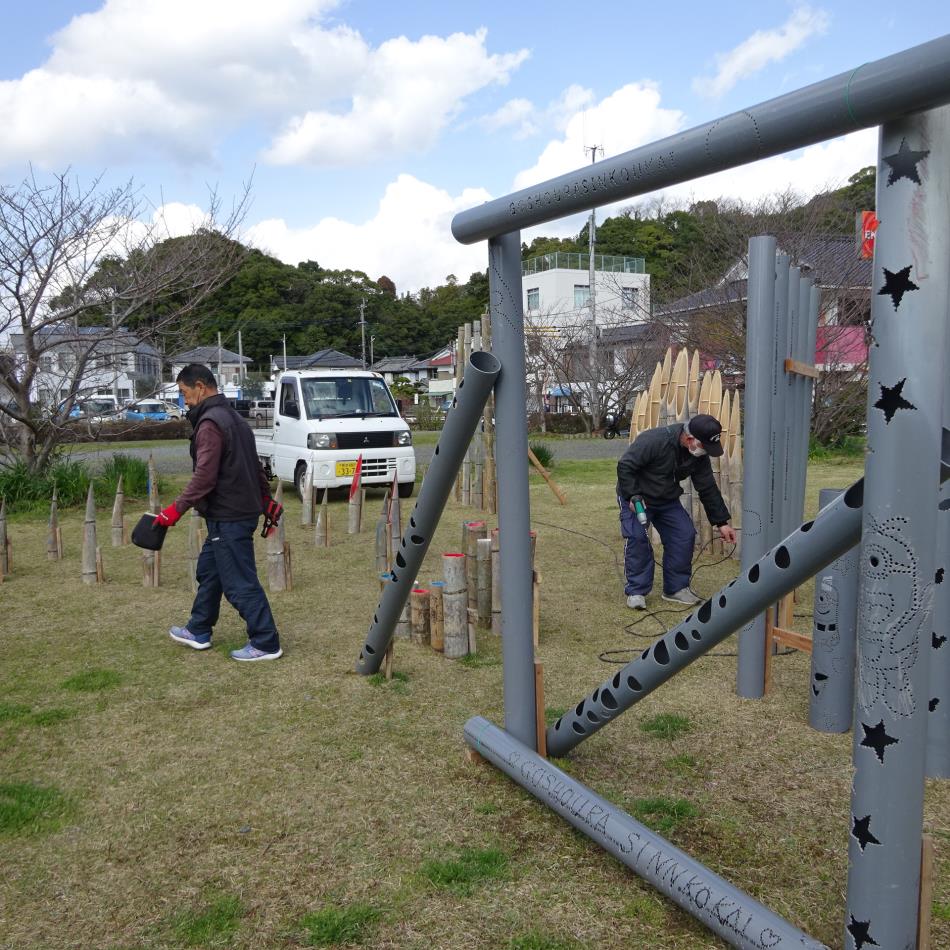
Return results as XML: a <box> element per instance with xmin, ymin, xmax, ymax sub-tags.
<box><xmin>514</xmin><ymin>82</ymin><xmax>683</xmax><ymax>190</ymax></box>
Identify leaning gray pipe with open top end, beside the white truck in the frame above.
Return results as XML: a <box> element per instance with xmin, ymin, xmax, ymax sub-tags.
<box><xmin>356</xmin><ymin>351</ymin><xmax>502</xmax><ymax>675</ymax></box>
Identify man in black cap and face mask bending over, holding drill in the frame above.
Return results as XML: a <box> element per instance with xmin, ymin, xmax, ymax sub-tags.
<box><xmin>617</xmin><ymin>415</ymin><xmax>736</xmax><ymax>610</ymax></box>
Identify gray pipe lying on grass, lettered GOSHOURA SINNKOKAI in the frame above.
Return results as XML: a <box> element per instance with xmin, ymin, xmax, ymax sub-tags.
<box><xmin>465</xmin><ymin>716</ymin><xmax>825</xmax><ymax>950</ymax></box>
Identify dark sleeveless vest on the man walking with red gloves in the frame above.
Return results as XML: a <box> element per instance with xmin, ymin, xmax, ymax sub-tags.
<box><xmin>188</xmin><ymin>393</ymin><xmax>266</xmax><ymax>521</ymax></box>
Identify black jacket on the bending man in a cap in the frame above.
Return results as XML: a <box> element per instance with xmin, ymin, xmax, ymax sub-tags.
<box><xmin>617</xmin><ymin>422</ymin><xmax>729</xmax><ymax>526</ymax></box>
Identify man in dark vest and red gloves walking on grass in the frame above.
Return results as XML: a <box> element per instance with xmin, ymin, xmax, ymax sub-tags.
<box><xmin>158</xmin><ymin>363</ymin><xmax>283</xmax><ymax>662</ymax></box>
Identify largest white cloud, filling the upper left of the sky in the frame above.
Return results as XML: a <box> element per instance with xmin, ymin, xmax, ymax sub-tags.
<box><xmin>0</xmin><ymin>0</ymin><xmax>527</xmax><ymax>167</ymax></box>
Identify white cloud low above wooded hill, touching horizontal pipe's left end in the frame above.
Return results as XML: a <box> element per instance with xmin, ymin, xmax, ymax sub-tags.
<box><xmin>246</xmin><ymin>175</ymin><xmax>491</xmax><ymax>293</ymax></box>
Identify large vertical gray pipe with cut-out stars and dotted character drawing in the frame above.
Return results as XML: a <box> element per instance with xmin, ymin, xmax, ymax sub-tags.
<box><xmin>845</xmin><ymin>106</ymin><xmax>950</xmax><ymax>947</ymax></box>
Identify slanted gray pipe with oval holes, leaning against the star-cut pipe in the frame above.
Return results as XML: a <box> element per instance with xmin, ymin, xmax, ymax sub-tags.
<box><xmin>547</xmin><ymin>480</ymin><xmax>863</xmax><ymax>756</ymax></box>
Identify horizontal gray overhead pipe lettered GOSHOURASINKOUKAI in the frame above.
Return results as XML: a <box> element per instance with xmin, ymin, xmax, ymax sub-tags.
<box><xmin>452</xmin><ymin>36</ymin><xmax>950</xmax><ymax>244</ymax></box>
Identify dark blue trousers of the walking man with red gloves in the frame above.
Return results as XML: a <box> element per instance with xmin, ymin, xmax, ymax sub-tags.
<box><xmin>188</xmin><ymin>518</ymin><xmax>280</xmax><ymax>653</ymax></box>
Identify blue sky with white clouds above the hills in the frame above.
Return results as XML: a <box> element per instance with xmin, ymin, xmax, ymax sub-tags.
<box><xmin>0</xmin><ymin>0</ymin><xmax>950</xmax><ymax>291</ymax></box>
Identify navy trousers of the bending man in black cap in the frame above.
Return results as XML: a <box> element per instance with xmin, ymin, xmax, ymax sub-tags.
<box><xmin>617</xmin><ymin>496</ymin><xmax>696</xmax><ymax>597</ymax></box>
